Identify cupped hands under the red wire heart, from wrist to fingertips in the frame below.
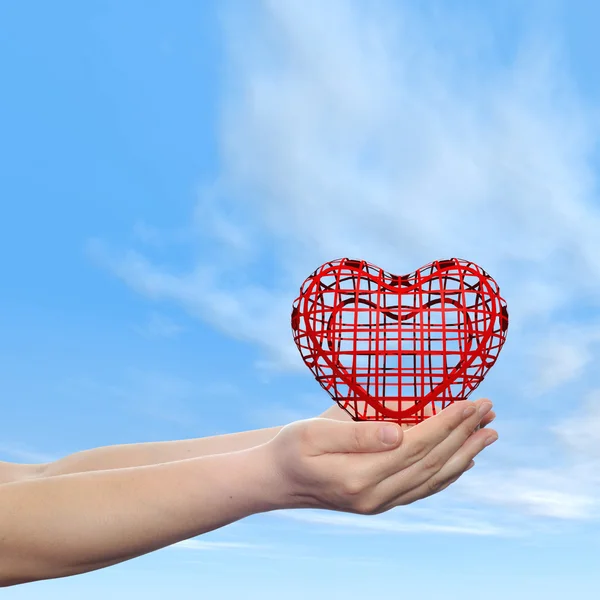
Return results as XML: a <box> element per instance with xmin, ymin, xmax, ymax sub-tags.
<box><xmin>264</xmin><ymin>400</ymin><xmax>497</xmax><ymax>514</ymax></box>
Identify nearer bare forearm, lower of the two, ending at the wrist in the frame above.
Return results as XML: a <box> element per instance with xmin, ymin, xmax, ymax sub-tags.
<box><xmin>0</xmin><ymin>447</ymin><xmax>283</xmax><ymax>586</ymax></box>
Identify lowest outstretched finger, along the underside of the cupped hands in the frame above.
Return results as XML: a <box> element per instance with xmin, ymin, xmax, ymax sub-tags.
<box><xmin>390</xmin><ymin>430</ymin><xmax>498</xmax><ymax>506</ymax></box>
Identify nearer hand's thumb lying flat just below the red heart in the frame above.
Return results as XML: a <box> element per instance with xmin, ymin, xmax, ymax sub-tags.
<box><xmin>313</xmin><ymin>419</ymin><xmax>403</xmax><ymax>453</ymax></box>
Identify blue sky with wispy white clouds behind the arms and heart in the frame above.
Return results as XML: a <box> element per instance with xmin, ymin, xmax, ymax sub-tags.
<box><xmin>0</xmin><ymin>0</ymin><xmax>600</xmax><ymax>600</ymax></box>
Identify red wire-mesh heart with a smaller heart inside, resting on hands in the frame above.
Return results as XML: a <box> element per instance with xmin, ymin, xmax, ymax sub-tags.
<box><xmin>292</xmin><ymin>258</ymin><xmax>508</xmax><ymax>424</ymax></box>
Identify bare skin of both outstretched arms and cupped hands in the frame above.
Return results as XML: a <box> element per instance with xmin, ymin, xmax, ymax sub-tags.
<box><xmin>0</xmin><ymin>400</ymin><xmax>497</xmax><ymax>586</ymax></box>
